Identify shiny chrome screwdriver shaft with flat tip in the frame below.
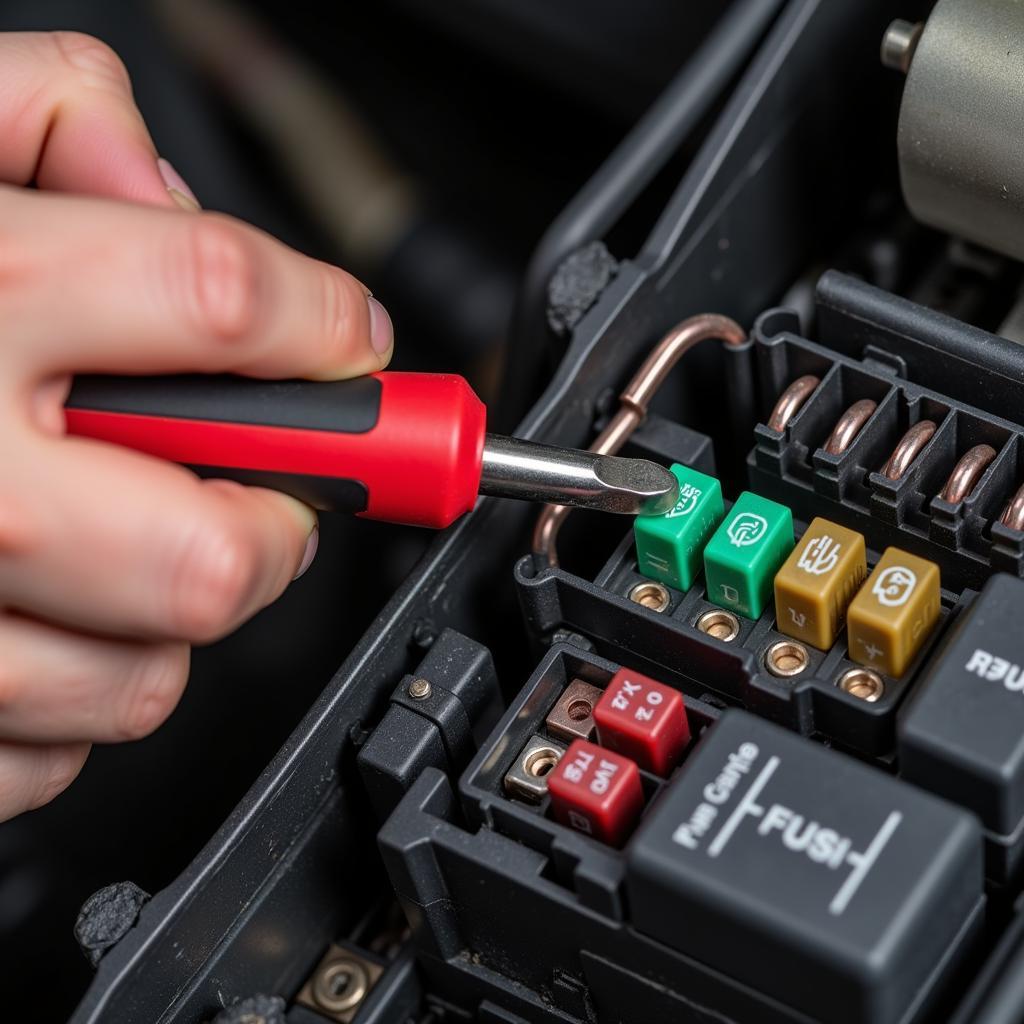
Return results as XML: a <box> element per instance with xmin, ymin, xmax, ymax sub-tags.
<box><xmin>480</xmin><ymin>434</ymin><xmax>679</xmax><ymax>515</ymax></box>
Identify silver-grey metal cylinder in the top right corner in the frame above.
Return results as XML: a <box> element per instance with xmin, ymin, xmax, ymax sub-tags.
<box><xmin>898</xmin><ymin>0</ymin><xmax>1024</xmax><ymax>259</ymax></box>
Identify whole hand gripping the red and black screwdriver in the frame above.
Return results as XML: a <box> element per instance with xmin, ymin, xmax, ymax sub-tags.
<box><xmin>0</xmin><ymin>33</ymin><xmax>392</xmax><ymax>819</ymax></box>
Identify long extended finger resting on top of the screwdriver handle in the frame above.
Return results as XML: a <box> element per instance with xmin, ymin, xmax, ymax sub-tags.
<box><xmin>0</xmin><ymin>188</ymin><xmax>392</xmax><ymax>379</ymax></box>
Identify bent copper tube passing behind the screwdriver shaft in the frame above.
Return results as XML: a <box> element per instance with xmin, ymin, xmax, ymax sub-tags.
<box><xmin>534</xmin><ymin>313</ymin><xmax>746</xmax><ymax>565</ymax></box>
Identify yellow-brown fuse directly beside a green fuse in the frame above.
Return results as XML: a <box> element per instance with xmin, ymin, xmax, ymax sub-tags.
<box><xmin>775</xmin><ymin>519</ymin><xmax>867</xmax><ymax>650</ymax></box>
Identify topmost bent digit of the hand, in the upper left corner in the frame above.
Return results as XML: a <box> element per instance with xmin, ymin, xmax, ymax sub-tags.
<box><xmin>0</xmin><ymin>32</ymin><xmax>174</xmax><ymax>206</ymax></box>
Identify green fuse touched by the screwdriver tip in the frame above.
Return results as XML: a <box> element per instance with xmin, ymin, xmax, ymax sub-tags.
<box><xmin>633</xmin><ymin>465</ymin><xmax>725</xmax><ymax>590</ymax></box>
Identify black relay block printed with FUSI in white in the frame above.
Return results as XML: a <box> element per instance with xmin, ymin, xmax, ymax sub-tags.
<box><xmin>627</xmin><ymin>711</ymin><xmax>982</xmax><ymax>1024</ymax></box>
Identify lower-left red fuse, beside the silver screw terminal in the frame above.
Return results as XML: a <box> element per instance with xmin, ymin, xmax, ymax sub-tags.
<box><xmin>548</xmin><ymin>739</ymin><xmax>643</xmax><ymax>846</ymax></box>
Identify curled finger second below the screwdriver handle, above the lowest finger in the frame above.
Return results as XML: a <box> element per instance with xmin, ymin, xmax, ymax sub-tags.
<box><xmin>0</xmin><ymin>613</ymin><xmax>189</xmax><ymax>743</ymax></box>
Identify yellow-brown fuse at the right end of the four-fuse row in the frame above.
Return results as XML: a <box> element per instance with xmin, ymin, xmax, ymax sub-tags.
<box><xmin>847</xmin><ymin>548</ymin><xmax>940</xmax><ymax>676</ymax></box>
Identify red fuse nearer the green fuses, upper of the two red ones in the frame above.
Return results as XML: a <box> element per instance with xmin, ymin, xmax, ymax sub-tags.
<box><xmin>594</xmin><ymin>669</ymin><xmax>690</xmax><ymax>775</ymax></box>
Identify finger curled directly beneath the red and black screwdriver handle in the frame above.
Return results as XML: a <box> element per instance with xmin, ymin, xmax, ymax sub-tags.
<box><xmin>0</xmin><ymin>438</ymin><xmax>315</xmax><ymax>643</ymax></box>
